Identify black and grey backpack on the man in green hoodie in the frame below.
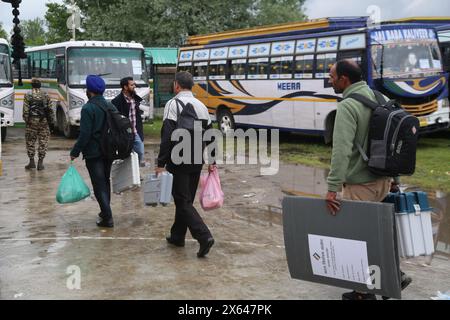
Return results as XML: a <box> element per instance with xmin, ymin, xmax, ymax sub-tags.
<box><xmin>349</xmin><ymin>90</ymin><xmax>420</xmax><ymax>177</ymax></box>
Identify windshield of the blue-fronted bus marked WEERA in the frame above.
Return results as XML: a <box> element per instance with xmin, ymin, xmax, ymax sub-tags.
<box><xmin>372</xmin><ymin>39</ymin><xmax>443</xmax><ymax>78</ymax></box>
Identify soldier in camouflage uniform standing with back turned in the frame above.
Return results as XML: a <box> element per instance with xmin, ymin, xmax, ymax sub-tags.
<box><xmin>23</xmin><ymin>79</ymin><xmax>53</xmax><ymax>170</ymax></box>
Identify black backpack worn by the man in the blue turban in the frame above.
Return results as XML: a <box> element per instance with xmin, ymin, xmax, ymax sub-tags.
<box><xmin>91</xmin><ymin>103</ymin><xmax>134</xmax><ymax>160</ymax></box>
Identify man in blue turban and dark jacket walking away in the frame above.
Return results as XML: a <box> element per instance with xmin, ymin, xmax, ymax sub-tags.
<box><xmin>70</xmin><ymin>75</ymin><xmax>115</xmax><ymax>228</ymax></box>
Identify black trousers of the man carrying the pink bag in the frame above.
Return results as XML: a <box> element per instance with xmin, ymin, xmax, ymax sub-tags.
<box><xmin>171</xmin><ymin>171</ymin><xmax>212</xmax><ymax>241</ymax></box>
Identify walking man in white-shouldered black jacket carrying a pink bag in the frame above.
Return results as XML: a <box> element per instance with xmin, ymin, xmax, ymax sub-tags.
<box><xmin>156</xmin><ymin>72</ymin><xmax>214</xmax><ymax>258</ymax></box>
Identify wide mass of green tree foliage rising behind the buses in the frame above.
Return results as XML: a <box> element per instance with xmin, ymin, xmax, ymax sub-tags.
<box><xmin>65</xmin><ymin>0</ymin><xmax>306</xmax><ymax>46</ymax></box>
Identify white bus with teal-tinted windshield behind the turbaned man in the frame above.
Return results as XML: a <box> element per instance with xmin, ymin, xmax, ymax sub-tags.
<box><xmin>16</xmin><ymin>41</ymin><xmax>153</xmax><ymax>138</ymax></box>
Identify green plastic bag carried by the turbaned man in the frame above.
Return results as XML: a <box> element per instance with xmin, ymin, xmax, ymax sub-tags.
<box><xmin>56</xmin><ymin>165</ymin><xmax>91</xmax><ymax>204</ymax></box>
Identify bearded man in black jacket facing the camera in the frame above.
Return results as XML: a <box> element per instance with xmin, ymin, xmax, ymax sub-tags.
<box><xmin>111</xmin><ymin>77</ymin><xmax>145</xmax><ymax>167</ymax></box>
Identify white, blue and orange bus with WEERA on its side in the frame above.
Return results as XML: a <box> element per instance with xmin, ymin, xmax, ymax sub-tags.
<box><xmin>178</xmin><ymin>17</ymin><xmax>450</xmax><ymax>142</ymax></box>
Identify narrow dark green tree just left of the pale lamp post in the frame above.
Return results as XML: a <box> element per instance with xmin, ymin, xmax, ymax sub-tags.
<box><xmin>45</xmin><ymin>3</ymin><xmax>71</xmax><ymax>43</ymax></box>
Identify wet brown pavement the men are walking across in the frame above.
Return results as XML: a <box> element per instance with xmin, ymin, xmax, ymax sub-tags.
<box><xmin>0</xmin><ymin>129</ymin><xmax>450</xmax><ymax>300</ymax></box>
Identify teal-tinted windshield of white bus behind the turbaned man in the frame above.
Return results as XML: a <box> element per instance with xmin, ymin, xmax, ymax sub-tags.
<box><xmin>68</xmin><ymin>48</ymin><xmax>148</xmax><ymax>86</ymax></box>
